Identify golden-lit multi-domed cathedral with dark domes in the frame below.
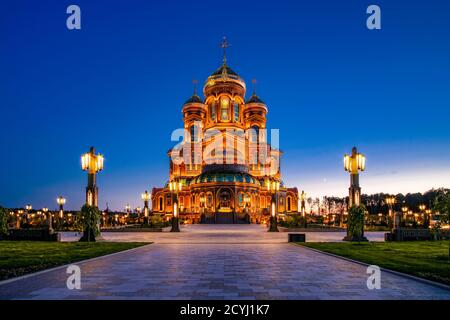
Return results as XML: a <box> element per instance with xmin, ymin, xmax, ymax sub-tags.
<box><xmin>152</xmin><ymin>47</ymin><xmax>298</xmax><ymax>223</ymax></box>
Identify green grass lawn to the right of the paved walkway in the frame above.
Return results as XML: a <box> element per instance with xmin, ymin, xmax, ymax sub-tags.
<box><xmin>299</xmin><ymin>241</ymin><xmax>450</xmax><ymax>284</ymax></box>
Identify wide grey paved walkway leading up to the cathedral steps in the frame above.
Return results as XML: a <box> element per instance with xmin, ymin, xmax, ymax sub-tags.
<box><xmin>0</xmin><ymin>225</ymin><xmax>450</xmax><ymax>300</ymax></box>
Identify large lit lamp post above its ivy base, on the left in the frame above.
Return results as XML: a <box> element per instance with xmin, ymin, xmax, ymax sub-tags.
<box><xmin>81</xmin><ymin>147</ymin><xmax>104</xmax><ymax>207</ymax></box>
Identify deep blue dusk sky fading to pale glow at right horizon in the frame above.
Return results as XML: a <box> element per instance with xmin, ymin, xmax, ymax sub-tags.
<box><xmin>0</xmin><ymin>0</ymin><xmax>450</xmax><ymax>209</ymax></box>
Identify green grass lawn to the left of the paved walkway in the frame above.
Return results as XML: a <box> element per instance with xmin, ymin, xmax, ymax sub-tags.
<box><xmin>0</xmin><ymin>241</ymin><xmax>147</xmax><ymax>280</ymax></box>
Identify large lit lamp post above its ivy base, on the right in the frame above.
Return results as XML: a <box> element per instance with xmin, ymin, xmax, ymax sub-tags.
<box><xmin>344</xmin><ymin>147</ymin><xmax>366</xmax><ymax>208</ymax></box>
